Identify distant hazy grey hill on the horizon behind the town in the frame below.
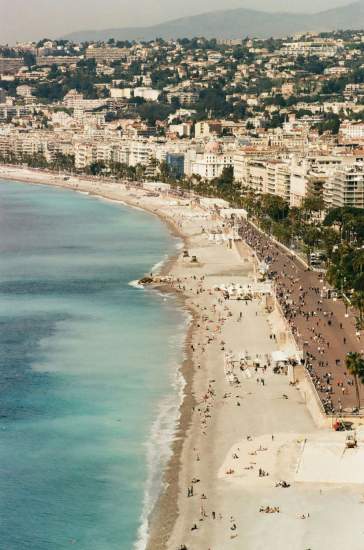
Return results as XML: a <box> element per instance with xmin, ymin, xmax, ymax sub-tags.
<box><xmin>64</xmin><ymin>0</ymin><xmax>364</xmax><ymax>42</ymax></box>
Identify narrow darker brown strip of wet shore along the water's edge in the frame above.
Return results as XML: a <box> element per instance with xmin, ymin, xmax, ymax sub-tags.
<box><xmin>0</xmin><ymin>166</ymin><xmax>197</xmax><ymax>550</ymax></box>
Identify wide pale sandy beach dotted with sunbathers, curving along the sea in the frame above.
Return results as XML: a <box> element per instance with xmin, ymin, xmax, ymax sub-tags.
<box><xmin>0</xmin><ymin>166</ymin><xmax>364</xmax><ymax>550</ymax></box>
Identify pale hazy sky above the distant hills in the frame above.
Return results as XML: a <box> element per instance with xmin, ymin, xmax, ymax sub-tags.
<box><xmin>0</xmin><ymin>0</ymin><xmax>350</xmax><ymax>44</ymax></box>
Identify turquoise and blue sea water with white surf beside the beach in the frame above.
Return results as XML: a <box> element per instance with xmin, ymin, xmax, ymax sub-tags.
<box><xmin>0</xmin><ymin>182</ymin><xmax>186</xmax><ymax>550</ymax></box>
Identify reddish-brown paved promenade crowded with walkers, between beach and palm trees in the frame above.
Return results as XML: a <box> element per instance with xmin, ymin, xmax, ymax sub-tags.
<box><xmin>240</xmin><ymin>222</ymin><xmax>364</xmax><ymax>414</ymax></box>
